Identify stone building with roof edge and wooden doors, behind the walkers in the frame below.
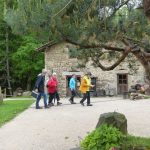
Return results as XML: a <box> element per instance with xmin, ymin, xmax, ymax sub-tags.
<box><xmin>37</xmin><ymin>42</ymin><xmax>144</xmax><ymax>97</ymax></box>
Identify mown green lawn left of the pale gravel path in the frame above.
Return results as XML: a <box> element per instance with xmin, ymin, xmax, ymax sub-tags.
<box><xmin>0</xmin><ymin>100</ymin><xmax>34</xmax><ymax>127</ymax></box>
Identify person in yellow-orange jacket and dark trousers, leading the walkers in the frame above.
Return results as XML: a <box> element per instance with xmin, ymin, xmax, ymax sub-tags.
<box><xmin>79</xmin><ymin>72</ymin><xmax>94</xmax><ymax>106</ymax></box>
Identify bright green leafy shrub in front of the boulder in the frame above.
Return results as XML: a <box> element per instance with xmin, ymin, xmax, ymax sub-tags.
<box><xmin>80</xmin><ymin>124</ymin><xmax>123</xmax><ymax>150</ymax></box>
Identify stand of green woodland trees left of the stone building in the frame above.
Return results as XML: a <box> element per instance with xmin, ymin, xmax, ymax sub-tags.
<box><xmin>0</xmin><ymin>0</ymin><xmax>44</xmax><ymax>92</ymax></box>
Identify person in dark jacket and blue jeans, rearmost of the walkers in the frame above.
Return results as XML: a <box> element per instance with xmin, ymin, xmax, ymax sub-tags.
<box><xmin>35</xmin><ymin>69</ymin><xmax>48</xmax><ymax>109</ymax></box>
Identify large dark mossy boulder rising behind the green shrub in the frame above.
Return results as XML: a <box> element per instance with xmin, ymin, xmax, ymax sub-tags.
<box><xmin>96</xmin><ymin>112</ymin><xmax>127</xmax><ymax>134</ymax></box>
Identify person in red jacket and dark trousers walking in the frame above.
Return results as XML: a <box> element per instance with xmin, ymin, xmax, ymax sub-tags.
<box><xmin>47</xmin><ymin>73</ymin><xmax>62</xmax><ymax>106</ymax></box>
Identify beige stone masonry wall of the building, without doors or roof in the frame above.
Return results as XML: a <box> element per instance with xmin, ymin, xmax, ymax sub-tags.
<box><xmin>45</xmin><ymin>43</ymin><xmax>144</xmax><ymax>96</ymax></box>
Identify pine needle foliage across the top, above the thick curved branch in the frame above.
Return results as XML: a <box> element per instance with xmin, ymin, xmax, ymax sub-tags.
<box><xmin>6</xmin><ymin>0</ymin><xmax>150</xmax><ymax>54</ymax></box>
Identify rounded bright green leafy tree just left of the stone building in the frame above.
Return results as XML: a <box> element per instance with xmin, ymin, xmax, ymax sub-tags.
<box><xmin>12</xmin><ymin>36</ymin><xmax>44</xmax><ymax>89</ymax></box>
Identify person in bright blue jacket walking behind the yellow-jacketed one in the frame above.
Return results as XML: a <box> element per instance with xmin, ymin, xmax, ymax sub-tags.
<box><xmin>69</xmin><ymin>74</ymin><xmax>76</xmax><ymax>104</ymax></box>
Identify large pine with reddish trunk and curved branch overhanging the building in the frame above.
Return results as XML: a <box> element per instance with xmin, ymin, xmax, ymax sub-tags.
<box><xmin>6</xmin><ymin>0</ymin><xmax>150</xmax><ymax>81</ymax></box>
